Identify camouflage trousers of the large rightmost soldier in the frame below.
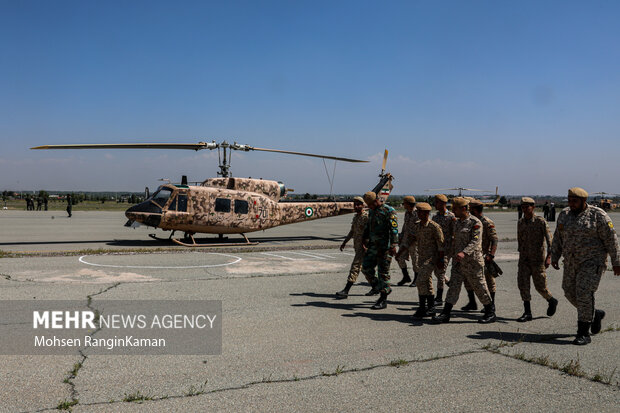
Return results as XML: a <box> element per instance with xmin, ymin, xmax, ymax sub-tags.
<box><xmin>562</xmin><ymin>259</ymin><xmax>605</xmax><ymax>323</ymax></box>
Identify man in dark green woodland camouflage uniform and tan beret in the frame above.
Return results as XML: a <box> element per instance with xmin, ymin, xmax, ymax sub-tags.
<box><xmin>362</xmin><ymin>191</ymin><xmax>398</xmax><ymax>310</ymax></box>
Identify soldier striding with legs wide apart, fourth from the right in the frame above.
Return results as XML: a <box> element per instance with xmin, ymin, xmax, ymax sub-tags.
<box><xmin>433</xmin><ymin>197</ymin><xmax>496</xmax><ymax>324</ymax></box>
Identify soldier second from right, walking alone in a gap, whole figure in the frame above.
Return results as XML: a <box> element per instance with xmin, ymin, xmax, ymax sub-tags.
<box><xmin>517</xmin><ymin>197</ymin><xmax>558</xmax><ymax>322</ymax></box>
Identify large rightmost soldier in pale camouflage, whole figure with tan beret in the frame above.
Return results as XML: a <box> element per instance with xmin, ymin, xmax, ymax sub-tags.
<box><xmin>551</xmin><ymin>188</ymin><xmax>620</xmax><ymax>345</ymax></box>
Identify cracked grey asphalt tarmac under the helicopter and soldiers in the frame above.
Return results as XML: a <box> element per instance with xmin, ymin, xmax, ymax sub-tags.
<box><xmin>0</xmin><ymin>211</ymin><xmax>620</xmax><ymax>412</ymax></box>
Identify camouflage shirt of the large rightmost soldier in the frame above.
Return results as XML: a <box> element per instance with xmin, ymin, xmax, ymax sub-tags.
<box><xmin>551</xmin><ymin>204</ymin><xmax>620</xmax><ymax>266</ymax></box>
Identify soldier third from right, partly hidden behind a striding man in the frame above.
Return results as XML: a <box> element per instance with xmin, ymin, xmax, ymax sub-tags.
<box><xmin>461</xmin><ymin>199</ymin><xmax>498</xmax><ymax>311</ymax></box>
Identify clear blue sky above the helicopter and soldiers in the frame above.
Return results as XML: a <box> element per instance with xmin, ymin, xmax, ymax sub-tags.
<box><xmin>0</xmin><ymin>0</ymin><xmax>620</xmax><ymax>194</ymax></box>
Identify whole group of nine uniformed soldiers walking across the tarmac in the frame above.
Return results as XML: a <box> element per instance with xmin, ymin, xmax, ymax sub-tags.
<box><xmin>336</xmin><ymin>188</ymin><xmax>620</xmax><ymax>345</ymax></box>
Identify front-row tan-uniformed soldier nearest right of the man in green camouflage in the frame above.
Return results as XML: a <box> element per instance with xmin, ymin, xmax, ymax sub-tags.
<box><xmin>398</xmin><ymin>202</ymin><xmax>444</xmax><ymax>319</ymax></box>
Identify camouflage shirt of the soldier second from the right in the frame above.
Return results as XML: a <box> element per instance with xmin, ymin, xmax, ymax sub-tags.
<box><xmin>517</xmin><ymin>215</ymin><xmax>551</xmax><ymax>262</ymax></box>
